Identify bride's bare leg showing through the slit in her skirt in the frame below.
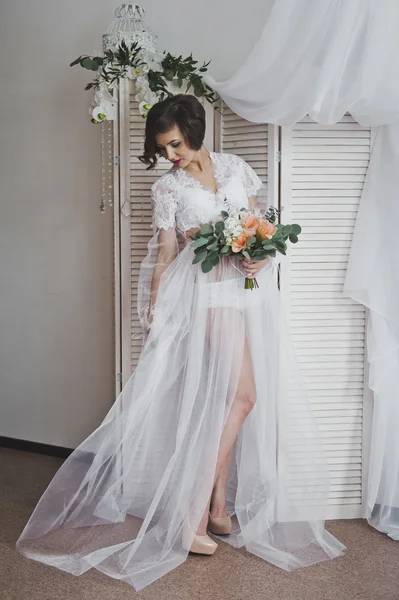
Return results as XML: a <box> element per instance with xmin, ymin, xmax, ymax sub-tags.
<box><xmin>197</xmin><ymin>324</ymin><xmax>256</xmax><ymax>535</ymax></box>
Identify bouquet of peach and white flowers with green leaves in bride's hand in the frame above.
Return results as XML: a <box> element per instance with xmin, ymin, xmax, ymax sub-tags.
<box><xmin>191</xmin><ymin>206</ymin><xmax>301</xmax><ymax>290</ymax></box>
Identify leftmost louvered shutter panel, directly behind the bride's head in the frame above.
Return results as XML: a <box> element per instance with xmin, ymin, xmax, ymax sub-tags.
<box><xmin>119</xmin><ymin>80</ymin><xmax>214</xmax><ymax>386</ymax></box>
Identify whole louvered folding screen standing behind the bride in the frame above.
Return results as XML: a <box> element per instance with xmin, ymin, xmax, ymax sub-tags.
<box><xmin>115</xmin><ymin>90</ymin><xmax>372</xmax><ymax>518</ymax></box>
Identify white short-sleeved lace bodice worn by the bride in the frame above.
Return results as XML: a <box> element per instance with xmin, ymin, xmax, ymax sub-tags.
<box><xmin>151</xmin><ymin>152</ymin><xmax>265</xmax><ymax>236</ymax></box>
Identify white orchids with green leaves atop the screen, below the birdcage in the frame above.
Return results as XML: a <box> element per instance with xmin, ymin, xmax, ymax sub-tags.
<box><xmin>70</xmin><ymin>40</ymin><xmax>218</xmax><ymax>124</ymax></box>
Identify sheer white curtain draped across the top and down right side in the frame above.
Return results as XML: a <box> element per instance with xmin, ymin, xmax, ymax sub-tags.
<box><xmin>205</xmin><ymin>0</ymin><xmax>399</xmax><ymax>539</ymax></box>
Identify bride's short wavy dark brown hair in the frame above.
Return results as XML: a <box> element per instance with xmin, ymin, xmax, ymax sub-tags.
<box><xmin>139</xmin><ymin>94</ymin><xmax>205</xmax><ymax>171</ymax></box>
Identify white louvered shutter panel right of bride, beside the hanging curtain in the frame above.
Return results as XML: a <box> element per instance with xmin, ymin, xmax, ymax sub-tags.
<box><xmin>281</xmin><ymin>114</ymin><xmax>372</xmax><ymax>518</ymax></box>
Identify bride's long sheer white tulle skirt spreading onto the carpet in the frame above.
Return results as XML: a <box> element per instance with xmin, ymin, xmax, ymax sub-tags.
<box><xmin>17</xmin><ymin>154</ymin><xmax>344</xmax><ymax>590</ymax></box>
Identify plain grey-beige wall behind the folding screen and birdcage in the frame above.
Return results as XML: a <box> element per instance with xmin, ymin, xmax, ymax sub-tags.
<box><xmin>0</xmin><ymin>0</ymin><xmax>276</xmax><ymax>447</ymax></box>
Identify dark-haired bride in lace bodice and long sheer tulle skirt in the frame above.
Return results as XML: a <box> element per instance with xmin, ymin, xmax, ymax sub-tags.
<box><xmin>17</xmin><ymin>94</ymin><xmax>345</xmax><ymax>590</ymax></box>
